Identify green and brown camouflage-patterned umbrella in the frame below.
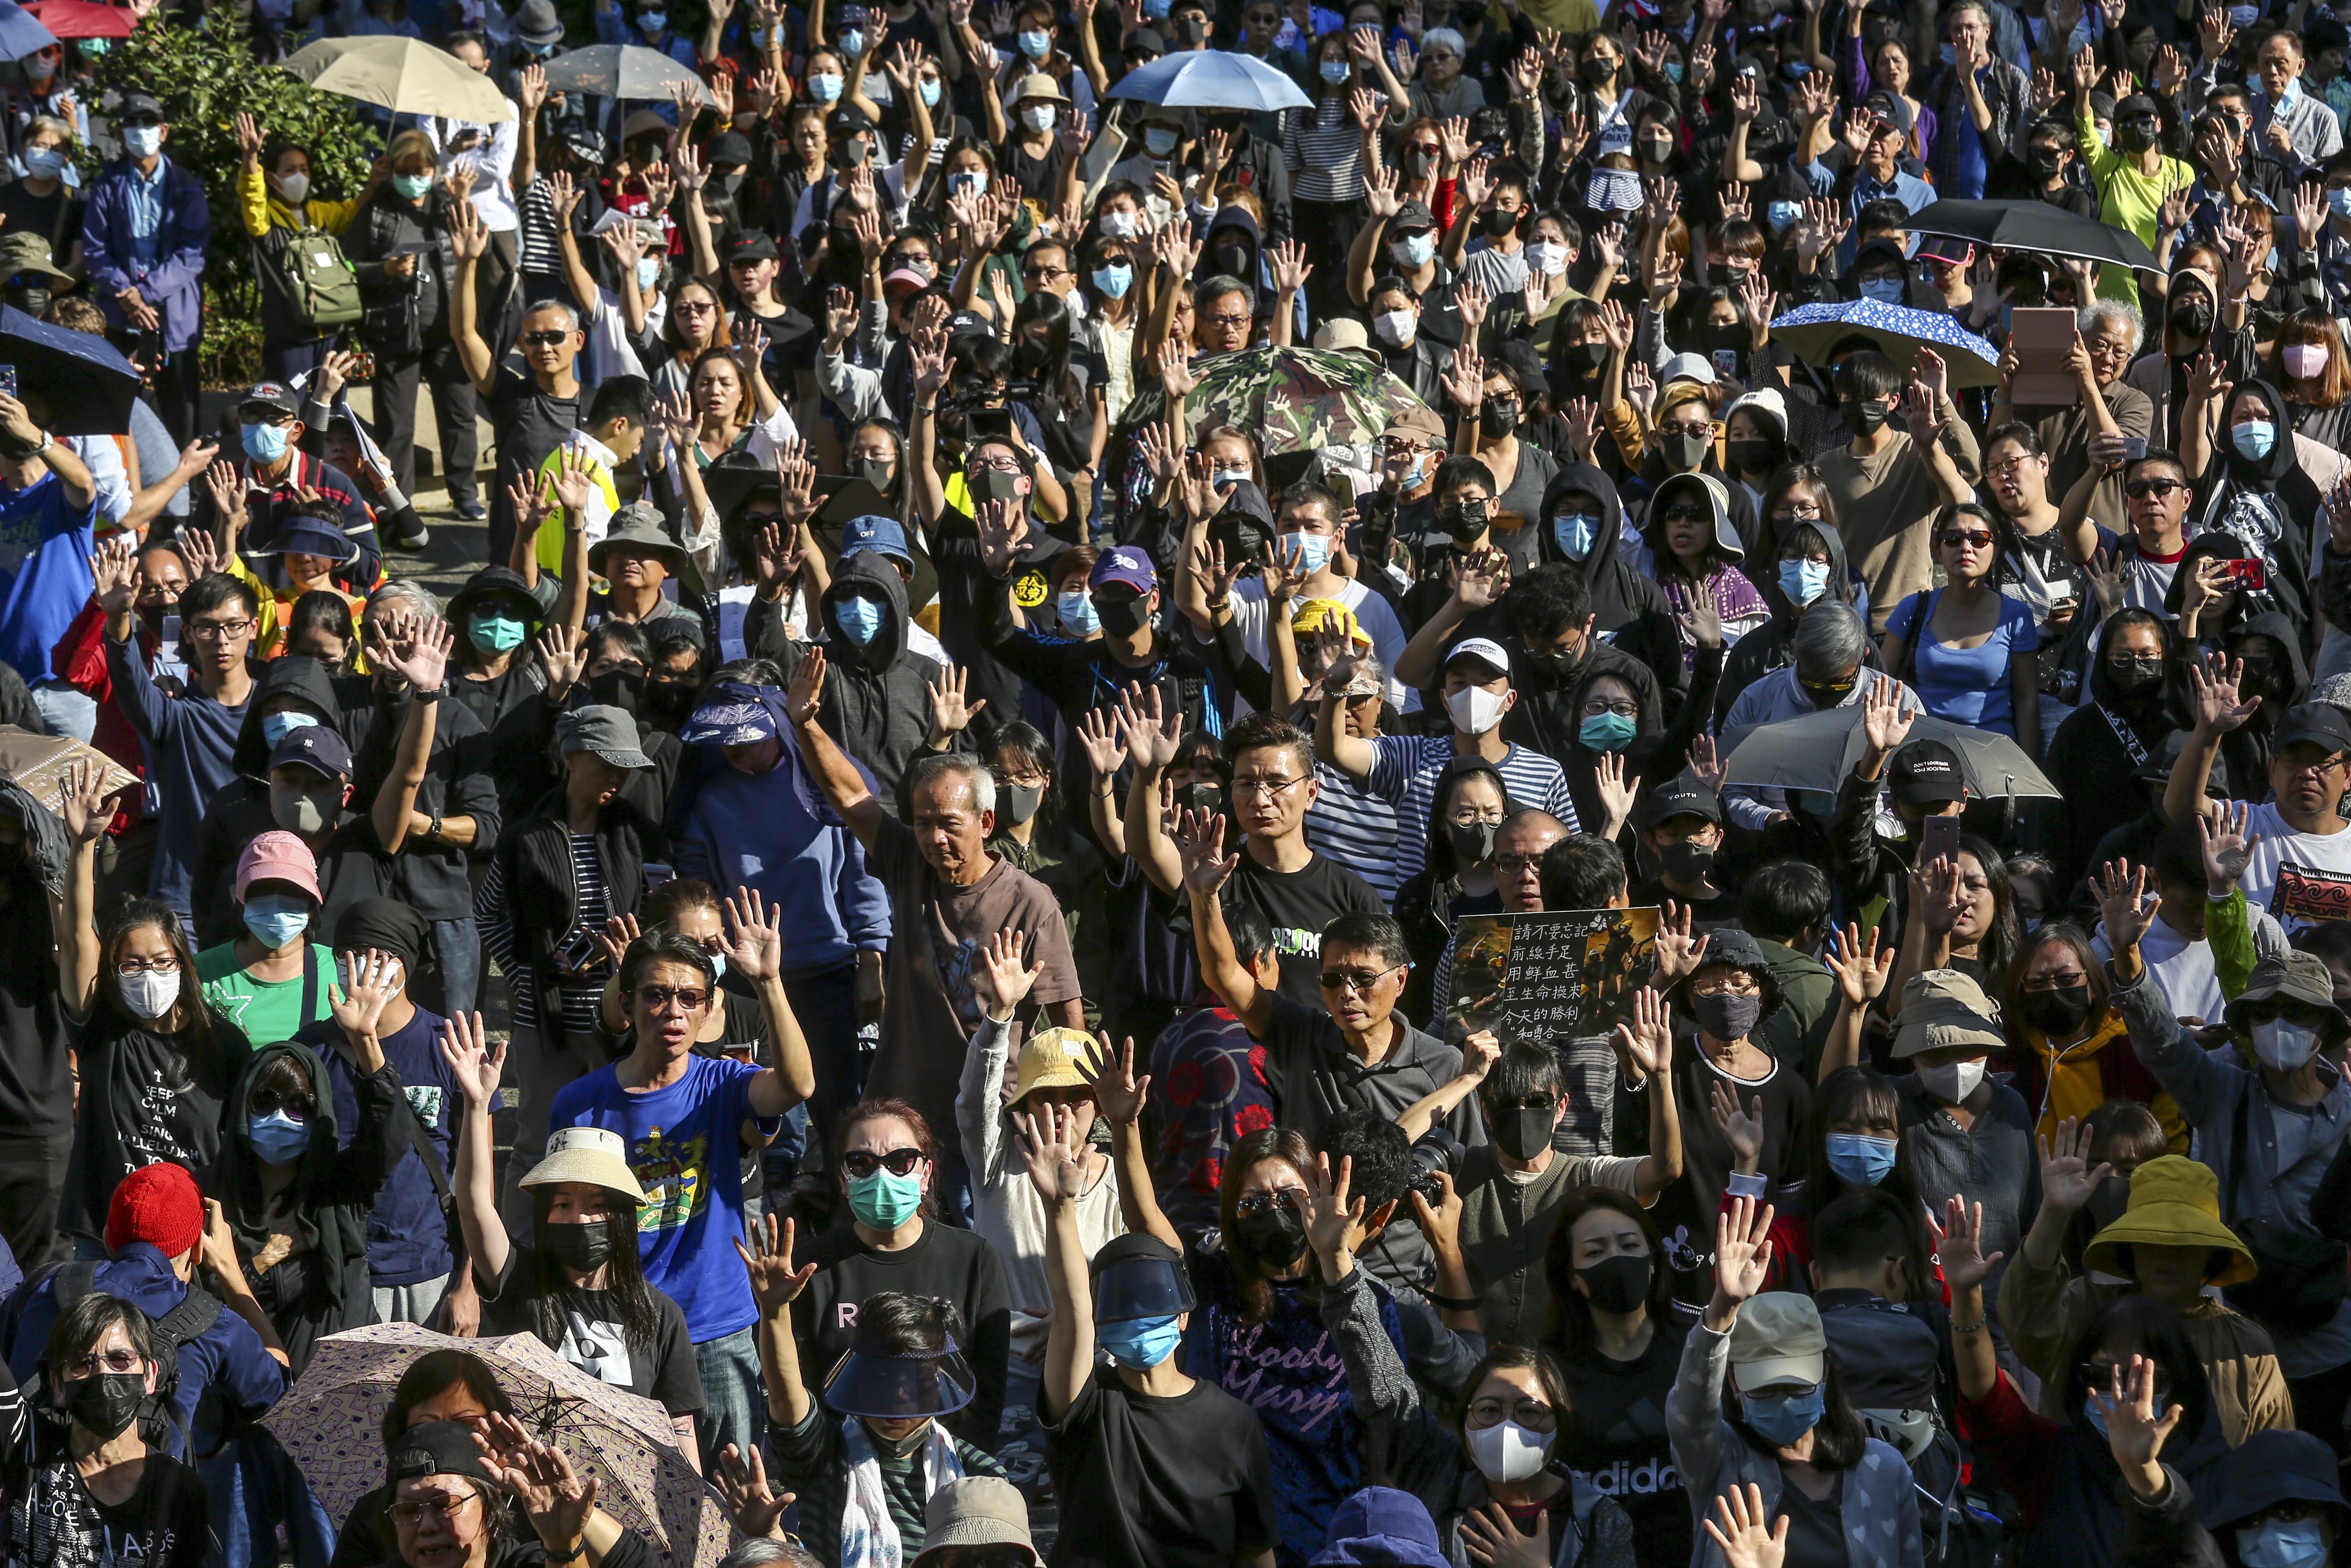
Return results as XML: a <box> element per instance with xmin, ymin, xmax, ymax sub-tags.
<box><xmin>1124</xmin><ymin>348</ymin><xmax>1425</xmax><ymax>456</ymax></box>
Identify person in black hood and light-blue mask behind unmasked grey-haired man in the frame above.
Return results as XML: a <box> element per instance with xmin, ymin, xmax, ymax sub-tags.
<box><xmin>771</xmin><ymin>550</ymin><xmax>938</xmax><ymax>816</ymax></box>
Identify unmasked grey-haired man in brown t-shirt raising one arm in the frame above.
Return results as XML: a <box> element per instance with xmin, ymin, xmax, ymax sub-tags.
<box><xmin>785</xmin><ymin>646</ymin><xmax>1086</xmax><ymax>1222</ymax></box>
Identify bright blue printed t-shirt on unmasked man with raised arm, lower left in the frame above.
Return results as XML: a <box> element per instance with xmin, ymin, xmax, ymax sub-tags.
<box><xmin>548</xmin><ymin>1055</ymin><xmax>759</xmax><ymax>1345</ymax></box>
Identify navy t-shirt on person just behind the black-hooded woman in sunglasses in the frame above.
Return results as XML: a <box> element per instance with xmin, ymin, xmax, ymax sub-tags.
<box><xmin>310</xmin><ymin>1009</ymin><xmax>466</xmax><ymax>1286</ymax></box>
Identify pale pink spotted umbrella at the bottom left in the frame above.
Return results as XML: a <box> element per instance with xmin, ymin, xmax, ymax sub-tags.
<box><xmin>261</xmin><ymin>1323</ymin><xmax>731</xmax><ymax>1568</ymax></box>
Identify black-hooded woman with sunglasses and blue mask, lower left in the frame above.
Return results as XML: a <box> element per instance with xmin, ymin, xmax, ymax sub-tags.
<box><xmin>202</xmin><ymin>1041</ymin><xmax>414</xmax><ymax>1375</ymax></box>
